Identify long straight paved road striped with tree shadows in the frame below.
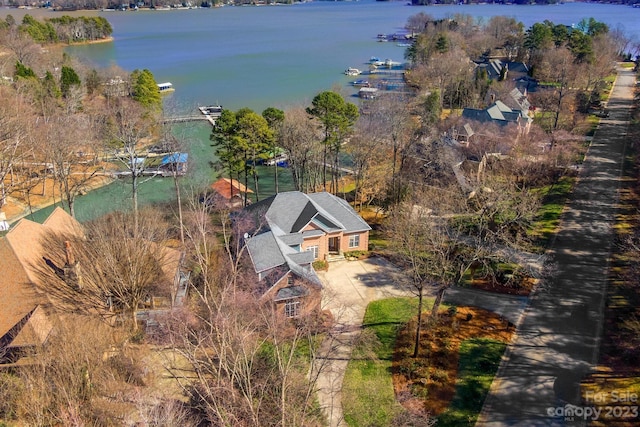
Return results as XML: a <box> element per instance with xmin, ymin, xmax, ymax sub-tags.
<box><xmin>477</xmin><ymin>70</ymin><xmax>635</xmax><ymax>427</ymax></box>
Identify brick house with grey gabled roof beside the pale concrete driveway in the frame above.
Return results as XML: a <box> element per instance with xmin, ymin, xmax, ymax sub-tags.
<box><xmin>236</xmin><ymin>191</ymin><xmax>371</xmax><ymax>317</ymax></box>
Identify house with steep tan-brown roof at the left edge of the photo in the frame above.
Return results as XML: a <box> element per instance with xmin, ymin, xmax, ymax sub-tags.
<box><xmin>0</xmin><ymin>208</ymin><xmax>82</xmax><ymax>362</ymax></box>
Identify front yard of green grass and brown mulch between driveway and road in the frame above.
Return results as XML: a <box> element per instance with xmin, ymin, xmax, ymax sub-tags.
<box><xmin>342</xmin><ymin>298</ymin><xmax>513</xmax><ymax>426</ymax></box>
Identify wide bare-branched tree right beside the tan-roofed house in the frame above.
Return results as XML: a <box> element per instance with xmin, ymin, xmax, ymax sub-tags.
<box><xmin>33</xmin><ymin>210</ymin><xmax>179</xmax><ymax>331</ymax></box>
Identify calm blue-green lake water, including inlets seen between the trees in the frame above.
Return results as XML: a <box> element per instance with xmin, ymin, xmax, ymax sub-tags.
<box><xmin>25</xmin><ymin>0</ymin><xmax>640</xmax><ymax>221</ymax></box>
